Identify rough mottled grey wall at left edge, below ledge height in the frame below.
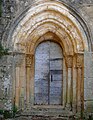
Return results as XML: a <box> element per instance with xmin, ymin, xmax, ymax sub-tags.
<box><xmin>0</xmin><ymin>56</ymin><xmax>13</xmax><ymax>110</ymax></box>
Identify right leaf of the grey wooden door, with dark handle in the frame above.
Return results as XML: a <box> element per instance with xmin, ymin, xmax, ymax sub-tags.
<box><xmin>49</xmin><ymin>42</ymin><xmax>63</xmax><ymax>104</ymax></box>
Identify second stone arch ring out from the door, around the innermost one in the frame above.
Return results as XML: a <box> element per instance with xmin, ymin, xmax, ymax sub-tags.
<box><xmin>24</xmin><ymin>23</ymin><xmax>74</xmax><ymax>54</ymax></box>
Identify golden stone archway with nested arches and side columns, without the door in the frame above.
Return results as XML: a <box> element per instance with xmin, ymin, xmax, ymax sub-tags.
<box><xmin>8</xmin><ymin>1</ymin><xmax>90</xmax><ymax>110</ymax></box>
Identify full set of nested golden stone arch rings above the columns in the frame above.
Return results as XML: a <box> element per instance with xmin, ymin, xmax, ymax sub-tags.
<box><xmin>12</xmin><ymin>1</ymin><xmax>88</xmax><ymax>55</ymax></box>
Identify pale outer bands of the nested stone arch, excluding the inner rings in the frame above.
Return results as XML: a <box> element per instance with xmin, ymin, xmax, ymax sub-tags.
<box><xmin>7</xmin><ymin>1</ymin><xmax>91</xmax><ymax>52</ymax></box>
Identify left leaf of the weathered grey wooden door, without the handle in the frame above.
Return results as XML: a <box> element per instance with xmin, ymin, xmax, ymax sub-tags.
<box><xmin>35</xmin><ymin>42</ymin><xmax>49</xmax><ymax>104</ymax></box>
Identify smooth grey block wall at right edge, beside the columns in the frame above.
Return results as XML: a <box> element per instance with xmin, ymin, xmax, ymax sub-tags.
<box><xmin>84</xmin><ymin>52</ymin><xmax>93</xmax><ymax>112</ymax></box>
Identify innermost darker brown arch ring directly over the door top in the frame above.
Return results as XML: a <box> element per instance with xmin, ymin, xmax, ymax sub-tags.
<box><xmin>28</xmin><ymin>29</ymin><xmax>74</xmax><ymax>55</ymax></box>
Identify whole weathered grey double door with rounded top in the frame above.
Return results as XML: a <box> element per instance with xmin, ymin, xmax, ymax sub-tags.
<box><xmin>34</xmin><ymin>41</ymin><xmax>63</xmax><ymax>105</ymax></box>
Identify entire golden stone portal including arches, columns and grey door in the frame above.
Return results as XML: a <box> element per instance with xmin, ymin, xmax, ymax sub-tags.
<box><xmin>9</xmin><ymin>1</ymin><xmax>86</xmax><ymax>111</ymax></box>
